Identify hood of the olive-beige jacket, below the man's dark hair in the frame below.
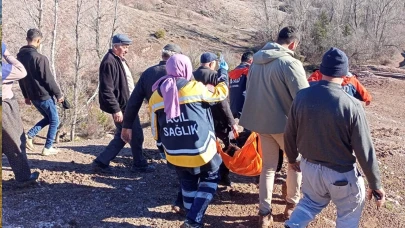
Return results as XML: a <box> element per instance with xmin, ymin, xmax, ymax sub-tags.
<box><xmin>253</xmin><ymin>42</ymin><xmax>295</xmax><ymax>64</ymax></box>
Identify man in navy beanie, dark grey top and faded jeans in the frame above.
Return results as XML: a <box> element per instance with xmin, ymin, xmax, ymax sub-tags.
<box><xmin>284</xmin><ymin>48</ymin><xmax>385</xmax><ymax>228</ymax></box>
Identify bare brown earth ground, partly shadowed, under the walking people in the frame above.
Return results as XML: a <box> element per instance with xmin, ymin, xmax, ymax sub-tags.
<box><xmin>2</xmin><ymin>72</ymin><xmax>405</xmax><ymax>228</ymax></box>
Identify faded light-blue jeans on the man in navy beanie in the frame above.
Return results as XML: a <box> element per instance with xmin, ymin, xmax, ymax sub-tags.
<box><xmin>285</xmin><ymin>159</ymin><xmax>366</xmax><ymax>228</ymax></box>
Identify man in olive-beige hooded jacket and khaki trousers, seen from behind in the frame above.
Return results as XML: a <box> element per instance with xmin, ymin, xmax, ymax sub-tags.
<box><xmin>239</xmin><ymin>26</ymin><xmax>309</xmax><ymax>227</ymax></box>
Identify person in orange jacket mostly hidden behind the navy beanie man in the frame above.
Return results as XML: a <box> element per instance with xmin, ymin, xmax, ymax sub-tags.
<box><xmin>308</xmin><ymin>70</ymin><xmax>372</xmax><ymax>106</ymax></box>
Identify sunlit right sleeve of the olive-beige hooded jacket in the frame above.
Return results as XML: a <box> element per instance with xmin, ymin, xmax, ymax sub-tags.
<box><xmin>283</xmin><ymin>59</ymin><xmax>309</xmax><ymax>99</ymax></box>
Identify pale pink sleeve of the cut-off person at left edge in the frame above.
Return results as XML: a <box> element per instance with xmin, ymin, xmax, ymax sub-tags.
<box><xmin>2</xmin><ymin>55</ymin><xmax>27</xmax><ymax>83</ymax></box>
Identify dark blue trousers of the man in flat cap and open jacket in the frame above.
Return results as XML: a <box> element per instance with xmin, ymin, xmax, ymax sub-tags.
<box><xmin>96</xmin><ymin>116</ymin><xmax>148</xmax><ymax>167</ymax></box>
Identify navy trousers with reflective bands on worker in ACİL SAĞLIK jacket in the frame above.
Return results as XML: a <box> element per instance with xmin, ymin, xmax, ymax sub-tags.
<box><xmin>176</xmin><ymin>167</ymin><xmax>219</xmax><ymax>224</ymax></box>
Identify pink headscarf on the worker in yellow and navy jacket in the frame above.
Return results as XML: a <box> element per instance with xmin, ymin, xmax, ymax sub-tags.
<box><xmin>152</xmin><ymin>54</ymin><xmax>193</xmax><ymax>119</ymax></box>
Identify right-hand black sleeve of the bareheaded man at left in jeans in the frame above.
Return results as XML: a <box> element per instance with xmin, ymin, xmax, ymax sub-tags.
<box><xmin>38</xmin><ymin>56</ymin><xmax>62</xmax><ymax>99</ymax></box>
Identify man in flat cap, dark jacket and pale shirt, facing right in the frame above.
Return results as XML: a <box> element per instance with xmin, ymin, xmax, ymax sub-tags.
<box><xmin>93</xmin><ymin>34</ymin><xmax>155</xmax><ymax>172</ymax></box>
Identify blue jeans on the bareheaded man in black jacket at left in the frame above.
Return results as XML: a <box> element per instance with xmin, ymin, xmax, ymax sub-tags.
<box><xmin>27</xmin><ymin>98</ymin><xmax>59</xmax><ymax>149</ymax></box>
